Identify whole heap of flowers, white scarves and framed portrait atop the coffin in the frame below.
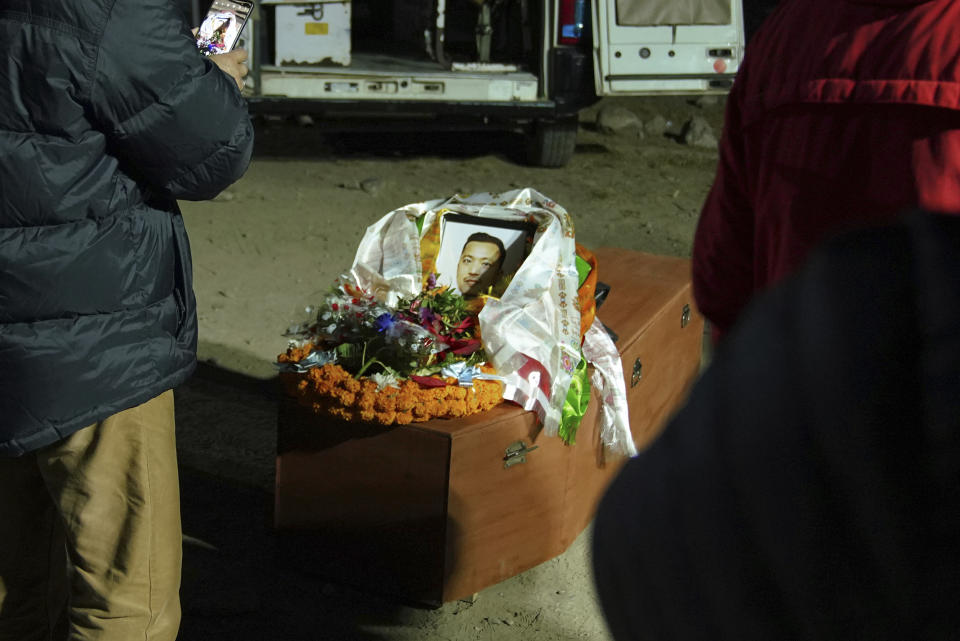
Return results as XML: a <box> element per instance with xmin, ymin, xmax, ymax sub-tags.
<box><xmin>278</xmin><ymin>189</ymin><xmax>636</xmax><ymax>455</ymax></box>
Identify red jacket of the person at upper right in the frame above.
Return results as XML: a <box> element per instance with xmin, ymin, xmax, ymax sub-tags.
<box><xmin>693</xmin><ymin>0</ymin><xmax>960</xmax><ymax>336</ymax></box>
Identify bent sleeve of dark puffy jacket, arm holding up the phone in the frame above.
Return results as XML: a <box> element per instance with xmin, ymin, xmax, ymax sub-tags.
<box><xmin>90</xmin><ymin>0</ymin><xmax>253</xmax><ymax>200</ymax></box>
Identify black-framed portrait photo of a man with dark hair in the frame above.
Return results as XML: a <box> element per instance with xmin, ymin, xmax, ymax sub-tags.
<box><xmin>435</xmin><ymin>214</ymin><xmax>537</xmax><ymax>298</ymax></box>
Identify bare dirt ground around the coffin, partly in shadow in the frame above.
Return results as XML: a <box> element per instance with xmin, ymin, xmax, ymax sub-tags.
<box><xmin>177</xmin><ymin>98</ymin><xmax>723</xmax><ymax>641</ymax></box>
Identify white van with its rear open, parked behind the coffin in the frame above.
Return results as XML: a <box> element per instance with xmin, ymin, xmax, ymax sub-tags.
<box><xmin>236</xmin><ymin>0</ymin><xmax>744</xmax><ymax>167</ymax></box>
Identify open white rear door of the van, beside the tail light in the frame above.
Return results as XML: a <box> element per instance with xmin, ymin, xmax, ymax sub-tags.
<box><xmin>592</xmin><ymin>0</ymin><xmax>746</xmax><ymax>96</ymax></box>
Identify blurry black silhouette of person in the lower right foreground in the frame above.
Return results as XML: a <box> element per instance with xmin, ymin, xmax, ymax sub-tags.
<box><xmin>592</xmin><ymin>213</ymin><xmax>960</xmax><ymax>641</ymax></box>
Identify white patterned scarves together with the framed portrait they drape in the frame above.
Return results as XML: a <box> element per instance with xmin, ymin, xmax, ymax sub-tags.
<box><xmin>351</xmin><ymin>189</ymin><xmax>636</xmax><ymax>454</ymax></box>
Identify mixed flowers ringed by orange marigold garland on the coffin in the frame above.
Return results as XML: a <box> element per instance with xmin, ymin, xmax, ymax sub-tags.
<box><xmin>277</xmin><ymin>274</ymin><xmax>503</xmax><ymax>425</ymax></box>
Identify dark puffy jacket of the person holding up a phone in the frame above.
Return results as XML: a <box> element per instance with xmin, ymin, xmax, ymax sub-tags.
<box><xmin>0</xmin><ymin>0</ymin><xmax>253</xmax><ymax>455</ymax></box>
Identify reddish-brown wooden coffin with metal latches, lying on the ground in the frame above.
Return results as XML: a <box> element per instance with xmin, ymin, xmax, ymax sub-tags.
<box><xmin>274</xmin><ymin>249</ymin><xmax>703</xmax><ymax>605</ymax></box>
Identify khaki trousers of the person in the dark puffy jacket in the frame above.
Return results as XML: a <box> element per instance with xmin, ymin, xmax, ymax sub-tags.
<box><xmin>0</xmin><ymin>391</ymin><xmax>182</xmax><ymax>641</ymax></box>
